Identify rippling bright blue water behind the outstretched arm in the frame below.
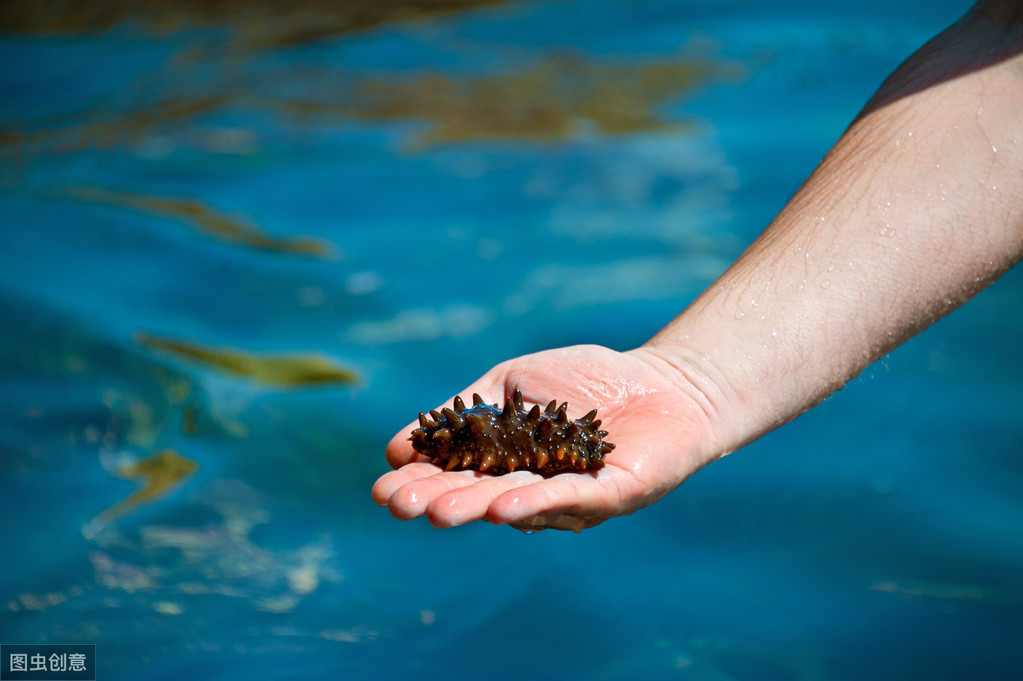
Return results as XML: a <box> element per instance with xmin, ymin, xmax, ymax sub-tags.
<box><xmin>0</xmin><ymin>0</ymin><xmax>1023</xmax><ymax>681</ymax></box>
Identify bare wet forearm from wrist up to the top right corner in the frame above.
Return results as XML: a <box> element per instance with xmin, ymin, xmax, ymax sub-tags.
<box><xmin>644</xmin><ymin>3</ymin><xmax>1023</xmax><ymax>455</ymax></box>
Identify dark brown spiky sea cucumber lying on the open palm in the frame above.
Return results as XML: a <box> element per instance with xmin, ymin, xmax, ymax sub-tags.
<box><xmin>409</xmin><ymin>389</ymin><xmax>615</xmax><ymax>476</ymax></box>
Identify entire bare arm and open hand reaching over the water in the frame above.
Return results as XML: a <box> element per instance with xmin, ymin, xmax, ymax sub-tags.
<box><xmin>372</xmin><ymin>1</ymin><xmax>1023</xmax><ymax>532</ymax></box>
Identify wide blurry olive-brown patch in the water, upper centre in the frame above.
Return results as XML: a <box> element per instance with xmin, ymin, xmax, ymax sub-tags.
<box><xmin>319</xmin><ymin>53</ymin><xmax>733</xmax><ymax>148</ymax></box>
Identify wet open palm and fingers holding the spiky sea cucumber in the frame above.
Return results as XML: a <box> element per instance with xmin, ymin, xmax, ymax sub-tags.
<box><xmin>372</xmin><ymin>346</ymin><xmax>719</xmax><ymax>532</ymax></box>
